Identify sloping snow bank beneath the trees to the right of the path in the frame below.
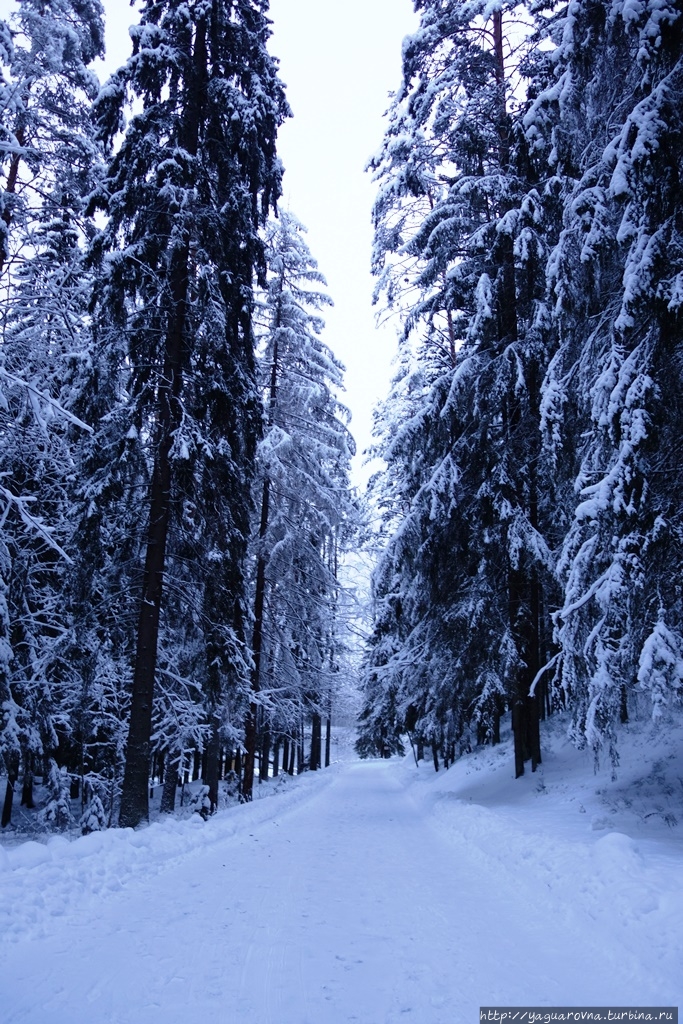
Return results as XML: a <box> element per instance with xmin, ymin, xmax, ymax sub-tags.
<box><xmin>403</xmin><ymin>719</ymin><xmax>683</xmax><ymax>995</ymax></box>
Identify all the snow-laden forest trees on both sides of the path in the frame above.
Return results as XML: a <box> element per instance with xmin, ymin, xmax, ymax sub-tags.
<box><xmin>0</xmin><ymin>0</ymin><xmax>683</xmax><ymax>831</ymax></box>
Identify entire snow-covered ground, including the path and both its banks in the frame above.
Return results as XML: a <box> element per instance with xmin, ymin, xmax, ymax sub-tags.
<box><xmin>0</xmin><ymin>712</ymin><xmax>683</xmax><ymax>1024</ymax></box>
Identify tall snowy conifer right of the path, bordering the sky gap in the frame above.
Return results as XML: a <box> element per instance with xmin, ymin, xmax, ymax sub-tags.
<box><xmin>358</xmin><ymin>2</ymin><xmax>551</xmax><ymax>774</ymax></box>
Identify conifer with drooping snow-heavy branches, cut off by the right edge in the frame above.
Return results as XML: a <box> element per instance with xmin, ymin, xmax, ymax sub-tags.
<box><xmin>528</xmin><ymin>2</ymin><xmax>683</xmax><ymax>763</ymax></box>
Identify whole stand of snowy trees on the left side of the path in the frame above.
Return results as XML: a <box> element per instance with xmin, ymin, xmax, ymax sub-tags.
<box><xmin>0</xmin><ymin>0</ymin><xmax>355</xmax><ymax>829</ymax></box>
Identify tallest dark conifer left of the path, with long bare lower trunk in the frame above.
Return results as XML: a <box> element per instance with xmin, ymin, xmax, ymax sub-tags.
<box><xmin>87</xmin><ymin>0</ymin><xmax>287</xmax><ymax>825</ymax></box>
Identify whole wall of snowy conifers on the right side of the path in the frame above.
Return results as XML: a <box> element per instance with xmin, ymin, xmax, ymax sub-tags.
<box><xmin>358</xmin><ymin>0</ymin><xmax>683</xmax><ymax>775</ymax></box>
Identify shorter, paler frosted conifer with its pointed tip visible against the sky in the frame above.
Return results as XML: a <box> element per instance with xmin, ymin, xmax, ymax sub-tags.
<box><xmin>243</xmin><ymin>212</ymin><xmax>354</xmax><ymax>800</ymax></box>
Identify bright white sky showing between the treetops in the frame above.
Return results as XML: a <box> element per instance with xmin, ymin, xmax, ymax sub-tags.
<box><xmin>0</xmin><ymin>0</ymin><xmax>417</xmax><ymax>483</ymax></box>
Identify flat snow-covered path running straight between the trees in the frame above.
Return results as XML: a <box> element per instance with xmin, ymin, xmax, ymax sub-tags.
<box><xmin>0</xmin><ymin>762</ymin><xmax>680</xmax><ymax>1024</ymax></box>
